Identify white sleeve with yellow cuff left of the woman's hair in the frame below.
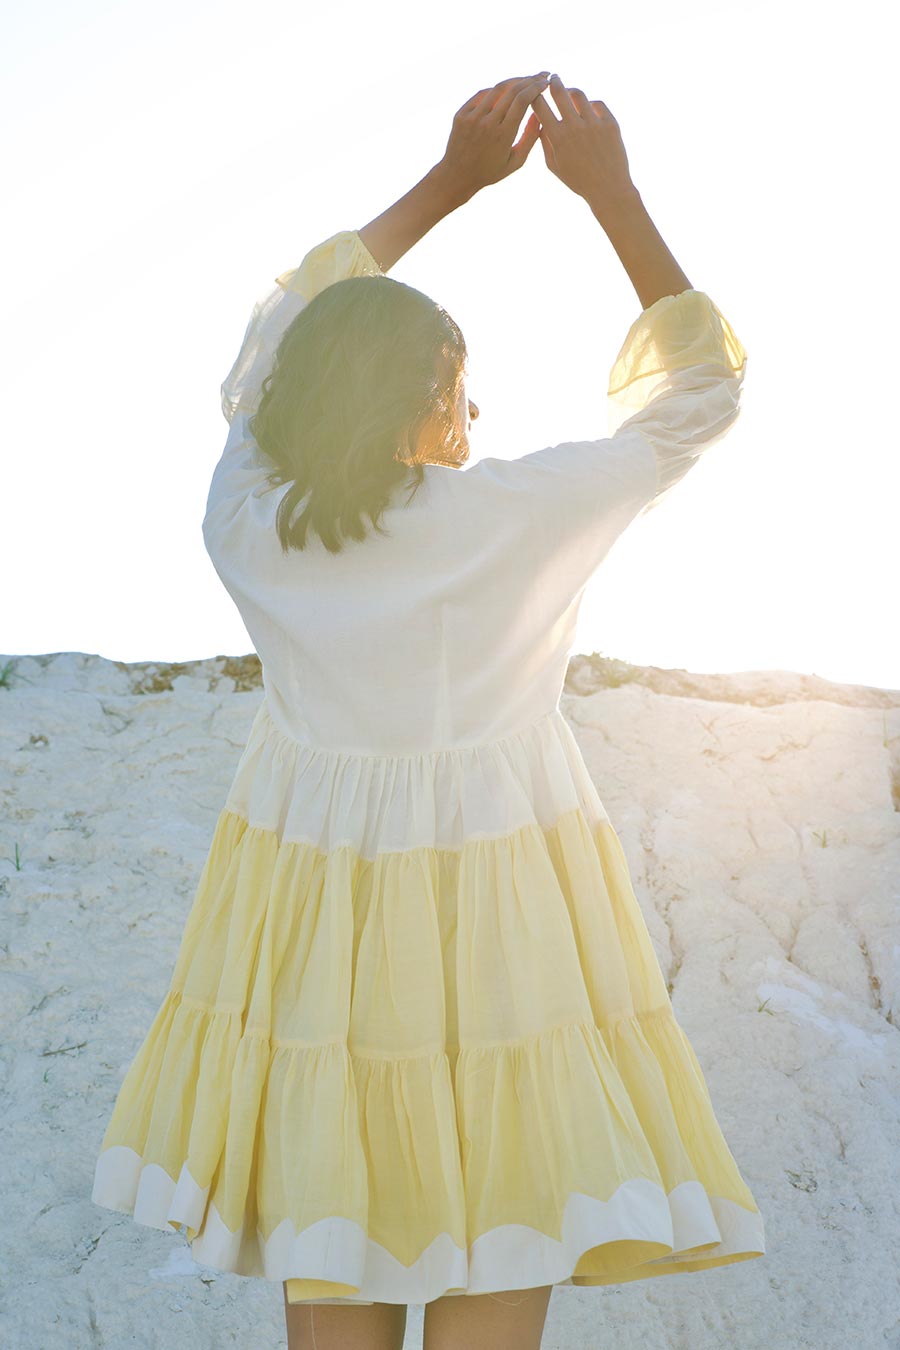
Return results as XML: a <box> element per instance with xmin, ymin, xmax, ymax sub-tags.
<box><xmin>202</xmin><ymin>230</ymin><xmax>382</xmax><ymax>539</ymax></box>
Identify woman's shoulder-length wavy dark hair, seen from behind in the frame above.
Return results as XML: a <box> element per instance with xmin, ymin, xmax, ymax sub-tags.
<box><xmin>250</xmin><ymin>277</ymin><xmax>468</xmax><ymax>554</ymax></box>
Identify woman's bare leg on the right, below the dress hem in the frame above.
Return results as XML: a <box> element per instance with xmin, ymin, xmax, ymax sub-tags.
<box><xmin>422</xmin><ymin>1284</ymin><xmax>553</xmax><ymax>1350</ymax></box>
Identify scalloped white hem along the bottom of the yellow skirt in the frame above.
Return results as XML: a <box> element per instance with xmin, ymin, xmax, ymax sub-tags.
<box><xmin>90</xmin><ymin>1145</ymin><xmax>765</xmax><ymax>1304</ymax></box>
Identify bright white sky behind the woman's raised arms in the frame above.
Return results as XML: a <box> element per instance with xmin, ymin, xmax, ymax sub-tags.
<box><xmin>0</xmin><ymin>0</ymin><xmax>900</xmax><ymax>687</ymax></box>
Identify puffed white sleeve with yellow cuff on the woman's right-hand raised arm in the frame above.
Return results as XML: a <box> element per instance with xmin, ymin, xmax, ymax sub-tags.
<box><xmin>467</xmin><ymin>290</ymin><xmax>746</xmax><ymax>593</ymax></box>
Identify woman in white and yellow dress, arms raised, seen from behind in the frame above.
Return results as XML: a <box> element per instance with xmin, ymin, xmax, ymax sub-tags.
<box><xmin>93</xmin><ymin>74</ymin><xmax>765</xmax><ymax>1350</ymax></box>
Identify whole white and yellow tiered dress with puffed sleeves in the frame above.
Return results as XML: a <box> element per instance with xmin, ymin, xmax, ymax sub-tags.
<box><xmin>94</xmin><ymin>231</ymin><xmax>764</xmax><ymax>1301</ymax></box>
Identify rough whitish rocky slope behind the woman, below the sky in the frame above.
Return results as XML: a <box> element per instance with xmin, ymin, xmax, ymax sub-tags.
<box><xmin>0</xmin><ymin>652</ymin><xmax>900</xmax><ymax>1350</ymax></box>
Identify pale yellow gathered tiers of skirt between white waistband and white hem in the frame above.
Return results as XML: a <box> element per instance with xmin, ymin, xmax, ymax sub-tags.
<box><xmin>103</xmin><ymin>810</ymin><xmax>756</xmax><ymax>1301</ymax></box>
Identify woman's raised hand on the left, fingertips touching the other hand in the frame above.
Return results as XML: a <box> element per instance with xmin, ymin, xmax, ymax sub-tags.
<box><xmin>437</xmin><ymin>72</ymin><xmax>549</xmax><ymax>196</ymax></box>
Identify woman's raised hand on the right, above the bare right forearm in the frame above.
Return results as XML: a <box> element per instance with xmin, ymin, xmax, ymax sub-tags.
<box><xmin>532</xmin><ymin>74</ymin><xmax>636</xmax><ymax>215</ymax></box>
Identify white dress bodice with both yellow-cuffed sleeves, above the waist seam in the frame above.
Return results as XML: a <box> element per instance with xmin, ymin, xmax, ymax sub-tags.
<box><xmin>202</xmin><ymin>231</ymin><xmax>746</xmax><ymax>767</ymax></box>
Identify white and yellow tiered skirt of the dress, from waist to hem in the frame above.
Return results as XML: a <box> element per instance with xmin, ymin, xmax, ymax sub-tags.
<box><xmin>92</xmin><ymin>698</ymin><xmax>765</xmax><ymax>1304</ymax></box>
